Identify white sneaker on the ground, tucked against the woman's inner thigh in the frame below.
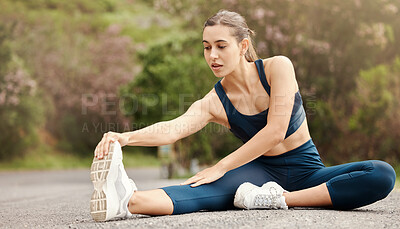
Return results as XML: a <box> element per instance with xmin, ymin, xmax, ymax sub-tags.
<box><xmin>233</xmin><ymin>181</ymin><xmax>288</xmax><ymax>210</ymax></box>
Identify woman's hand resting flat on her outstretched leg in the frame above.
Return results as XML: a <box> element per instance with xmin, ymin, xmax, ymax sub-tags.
<box><xmin>181</xmin><ymin>165</ymin><xmax>226</xmax><ymax>187</ymax></box>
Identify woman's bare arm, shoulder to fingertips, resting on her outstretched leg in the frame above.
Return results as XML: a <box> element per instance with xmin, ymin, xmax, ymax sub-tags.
<box><xmin>182</xmin><ymin>56</ymin><xmax>297</xmax><ymax>187</ymax></box>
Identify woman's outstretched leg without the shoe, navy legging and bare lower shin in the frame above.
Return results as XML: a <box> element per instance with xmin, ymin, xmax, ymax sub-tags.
<box><xmin>128</xmin><ymin>158</ymin><xmax>281</xmax><ymax>215</ymax></box>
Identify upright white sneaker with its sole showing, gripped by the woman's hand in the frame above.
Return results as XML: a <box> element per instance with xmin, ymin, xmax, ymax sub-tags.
<box><xmin>90</xmin><ymin>141</ymin><xmax>137</xmax><ymax>221</ymax></box>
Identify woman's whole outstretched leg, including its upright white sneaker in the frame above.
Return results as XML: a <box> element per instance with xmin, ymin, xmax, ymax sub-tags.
<box><xmin>91</xmin><ymin>142</ymin><xmax>286</xmax><ymax>221</ymax></box>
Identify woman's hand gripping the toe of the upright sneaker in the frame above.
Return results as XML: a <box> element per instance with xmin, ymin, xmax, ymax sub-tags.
<box><xmin>94</xmin><ymin>131</ymin><xmax>128</xmax><ymax>159</ymax></box>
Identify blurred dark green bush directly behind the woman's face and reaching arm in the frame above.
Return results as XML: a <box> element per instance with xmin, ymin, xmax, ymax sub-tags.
<box><xmin>123</xmin><ymin>31</ymin><xmax>209</xmax><ymax>123</ymax></box>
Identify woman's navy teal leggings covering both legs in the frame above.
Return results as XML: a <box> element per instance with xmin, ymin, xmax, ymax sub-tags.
<box><xmin>162</xmin><ymin>139</ymin><xmax>396</xmax><ymax>214</ymax></box>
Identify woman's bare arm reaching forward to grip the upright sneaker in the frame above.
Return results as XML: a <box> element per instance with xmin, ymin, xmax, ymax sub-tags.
<box><xmin>94</xmin><ymin>93</ymin><xmax>213</xmax><ymax>158</ymax></box>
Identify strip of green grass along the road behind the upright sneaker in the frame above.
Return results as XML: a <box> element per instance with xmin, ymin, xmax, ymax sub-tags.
<box><xmin>0</xmin><ymin>145</ymin><xmax>160</xmax><ymax>171</ymax></box>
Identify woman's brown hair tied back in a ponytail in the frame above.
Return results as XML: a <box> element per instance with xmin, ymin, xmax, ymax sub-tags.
<box><xmin>203</xmin><ymin>10</ymin><xmax>258</xmax><ymax>62</ymax></box>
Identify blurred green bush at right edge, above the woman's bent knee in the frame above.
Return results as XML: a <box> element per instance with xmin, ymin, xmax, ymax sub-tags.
<box><xmin>348</xmin><ymin>58</ymin><xmax>400</xmax><ymax>161</ymax></box>
